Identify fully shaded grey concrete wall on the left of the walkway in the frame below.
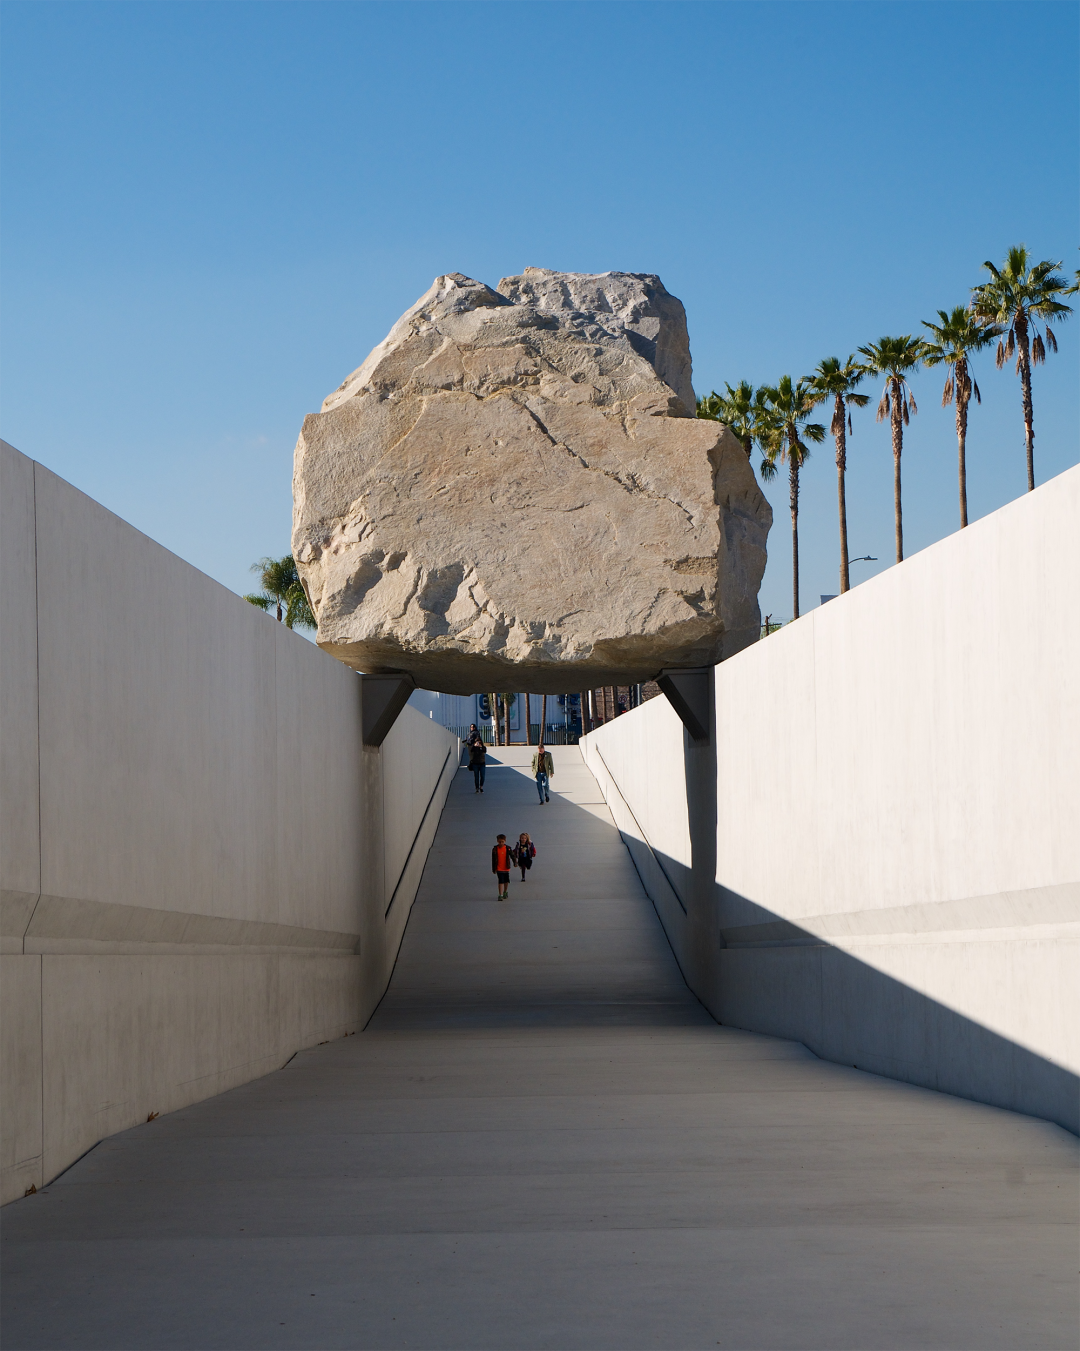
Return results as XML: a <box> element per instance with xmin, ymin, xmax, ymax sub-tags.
<box><xmin>0</xmin><ymin>443</ymin><xmax>458</xmax><ymax>1201</ymax></box>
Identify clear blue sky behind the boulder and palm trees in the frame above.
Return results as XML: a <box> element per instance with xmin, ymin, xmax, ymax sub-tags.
<box><xmin>0</xmin><ymin>0</ymin><xmax>1080</xmax><ymax>617</ymax></box>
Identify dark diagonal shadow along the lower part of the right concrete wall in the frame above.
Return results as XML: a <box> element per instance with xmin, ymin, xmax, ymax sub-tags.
<box><xmin>613</xmin><ymin>738</ymin><xmax>1080</xmax><ymax>1135</ymax></box>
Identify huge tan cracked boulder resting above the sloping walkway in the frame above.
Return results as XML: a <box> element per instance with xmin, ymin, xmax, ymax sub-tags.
<box><xmin>293</xmin><ymin>267</ymin><xmax>772</xmax><ymax>694</ymax></box>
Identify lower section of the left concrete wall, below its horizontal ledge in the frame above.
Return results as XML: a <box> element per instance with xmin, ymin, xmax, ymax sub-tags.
<box><xmin>0</xmin><ymin>954</ymin><xmax>365</xmax><ymax>1201</ymax></box>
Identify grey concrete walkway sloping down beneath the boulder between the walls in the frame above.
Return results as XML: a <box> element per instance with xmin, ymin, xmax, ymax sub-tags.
<box><xmin>0</xmin><ymin>748</ymin><xmax>1080</xmax><ymax>1351</ymax></box>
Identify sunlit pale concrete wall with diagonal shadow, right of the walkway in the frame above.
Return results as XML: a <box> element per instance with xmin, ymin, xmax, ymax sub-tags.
<box><xmin>583</xmin><ymin>469</ymin><xmax>1080</xmax><ymax>1132</ymax></box>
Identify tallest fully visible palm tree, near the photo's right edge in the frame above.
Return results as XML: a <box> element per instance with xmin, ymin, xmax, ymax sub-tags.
<box><xmin>971</xmin><ymin>245</ymin><xmax>1072</xmax><ymax>493</ymax></box>
